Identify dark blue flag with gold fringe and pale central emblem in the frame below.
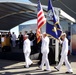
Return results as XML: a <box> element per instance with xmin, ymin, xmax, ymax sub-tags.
<box><xmin>46</xmin><ymin>0</ymin><xmax>62</xmax><ymax>39</ymax></box>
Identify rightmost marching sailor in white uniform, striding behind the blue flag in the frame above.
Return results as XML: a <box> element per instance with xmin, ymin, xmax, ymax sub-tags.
<box><xmin>54</xmin><ymin>33</ymin><xmax>73</xmax><ymax>74</ymax></box>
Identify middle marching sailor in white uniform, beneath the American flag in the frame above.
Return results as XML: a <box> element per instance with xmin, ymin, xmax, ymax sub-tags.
<box><xmin>39</xmin><ymin>32</ymin><xmax>51</xmax><ymax>71</ymax></box>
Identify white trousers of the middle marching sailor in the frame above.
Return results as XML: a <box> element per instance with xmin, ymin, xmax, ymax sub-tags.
<box><xmin>40</xmin><ymin>52</ymin><xmax>50</xmax><ymax>70</ymax></box>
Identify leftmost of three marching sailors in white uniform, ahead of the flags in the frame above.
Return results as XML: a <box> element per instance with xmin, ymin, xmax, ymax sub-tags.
<box><xmin>23</xmin><ymin>35</ymin><xmax>33</xmax><ymax>68</ymax></box>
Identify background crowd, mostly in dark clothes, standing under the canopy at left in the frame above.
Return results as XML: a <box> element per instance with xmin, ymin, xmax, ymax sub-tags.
<box><xmin>0</xmin><ymin>30</ymin><xmax>37</xmax><ymax>49</ymax></box>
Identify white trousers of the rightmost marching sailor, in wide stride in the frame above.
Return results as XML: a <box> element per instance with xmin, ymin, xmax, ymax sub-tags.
<box><xmin>56</xmin><ymin>55</ymin><xmax>73</xmax><ymax>72</ymax></box>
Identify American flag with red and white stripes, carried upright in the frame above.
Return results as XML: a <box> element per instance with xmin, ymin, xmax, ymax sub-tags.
<box><xmin>37</xmin><ymin>0</ymin><xmax>46</xmax><ymax>43</ymax></box>
